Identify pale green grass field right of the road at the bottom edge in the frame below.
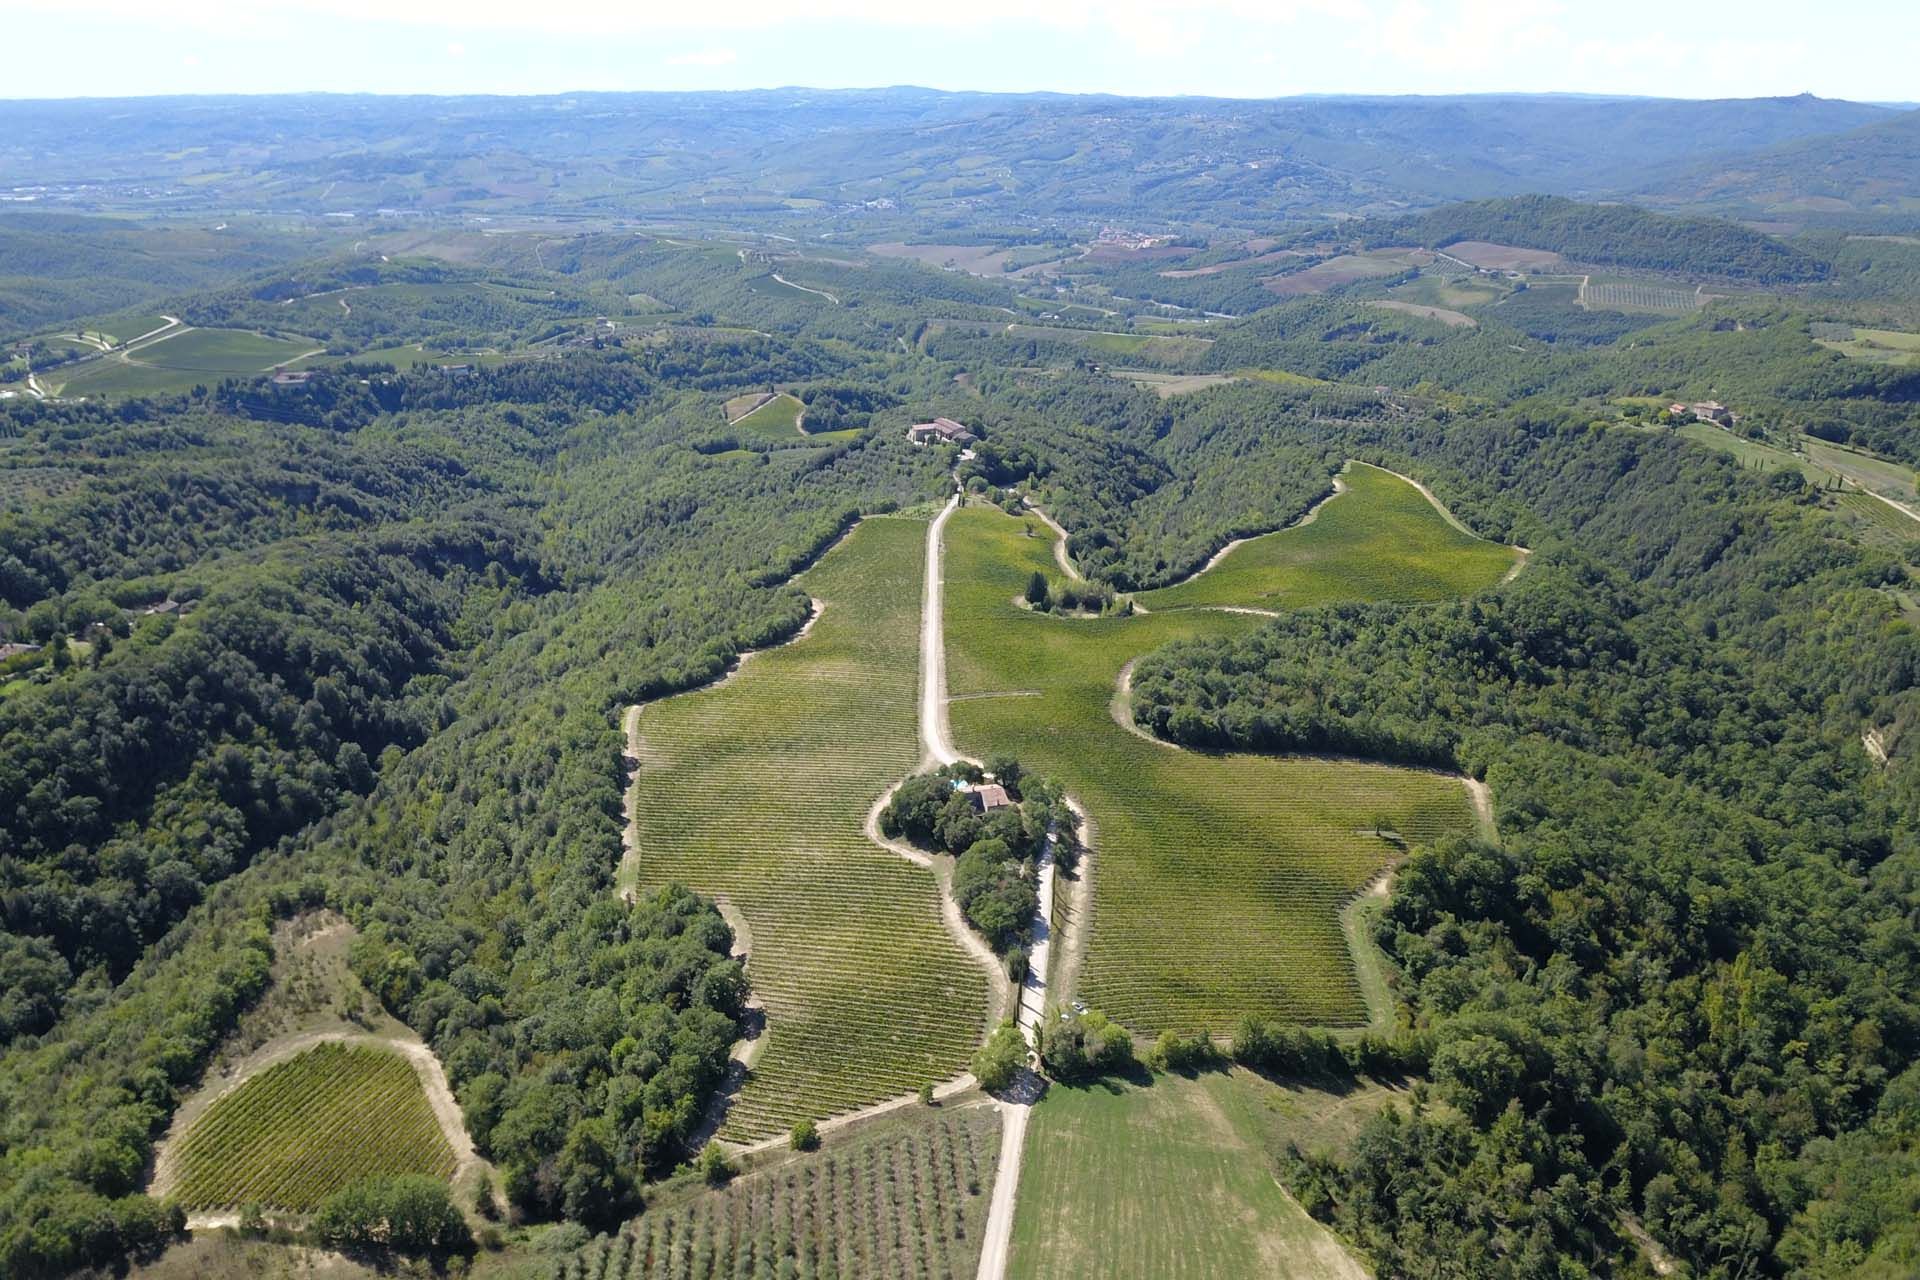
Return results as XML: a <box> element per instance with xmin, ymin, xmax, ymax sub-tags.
<box><xmin>1008</xmin><ymin>1071</ymin><xmax>1386</xmax><ymax>1280</ymax></box>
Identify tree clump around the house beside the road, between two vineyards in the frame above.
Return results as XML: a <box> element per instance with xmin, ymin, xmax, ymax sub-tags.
<box><xmin>879</xmin><ymin>756</ymin><xmax>1075</xmax><ymax>959</ymax></box>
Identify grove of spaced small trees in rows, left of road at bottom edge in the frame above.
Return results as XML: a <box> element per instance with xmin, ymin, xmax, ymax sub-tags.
<box><xmin>553</xmin><ymin>1107</ymin><xmax>1000</xmax><ymax>1280</ymax></box>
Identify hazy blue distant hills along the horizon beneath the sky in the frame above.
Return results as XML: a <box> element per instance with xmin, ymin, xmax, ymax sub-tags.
<box><xmin>0</xmin><ymin>88</ymin><xmax>1905</xmax><ymax>228</ymax></box>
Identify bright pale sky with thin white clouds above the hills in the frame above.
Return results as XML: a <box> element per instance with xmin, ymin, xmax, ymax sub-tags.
<box><xmin>0</xmin><ymin>0</ymin><xmax>1920</xmax><ymax>102</ymax></box>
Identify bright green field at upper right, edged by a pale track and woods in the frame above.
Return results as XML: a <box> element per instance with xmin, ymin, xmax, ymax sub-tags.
<box><xmin>1137</xmin><ymin>462</ymin><xmax>1513</xmax><ymax>610</ymax></box>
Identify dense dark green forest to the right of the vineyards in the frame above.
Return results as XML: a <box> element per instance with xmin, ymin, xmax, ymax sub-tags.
<box><xmin>1135</xmin><ymin>422</ymin><xmax>1920</xmax><ymax>1276</ymax></box>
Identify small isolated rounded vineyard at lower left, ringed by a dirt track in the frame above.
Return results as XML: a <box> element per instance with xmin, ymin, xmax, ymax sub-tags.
<box><xmin>171</xmin><ymin>1042</ymin><xmax>453</xmax><ymax>1213</ymax></box>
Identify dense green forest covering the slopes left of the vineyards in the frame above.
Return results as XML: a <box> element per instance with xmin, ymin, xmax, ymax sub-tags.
<box><xmin>0</xmin><ymin>345</ymin><xmax>943</xmax><ymax>1276</ymax></box>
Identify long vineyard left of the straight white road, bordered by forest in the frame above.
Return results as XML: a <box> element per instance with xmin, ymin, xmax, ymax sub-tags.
<box><xmin>622</xmin><ymin>516</ymin><xmax>987</xmax><ymax>1140</ymax></box>
